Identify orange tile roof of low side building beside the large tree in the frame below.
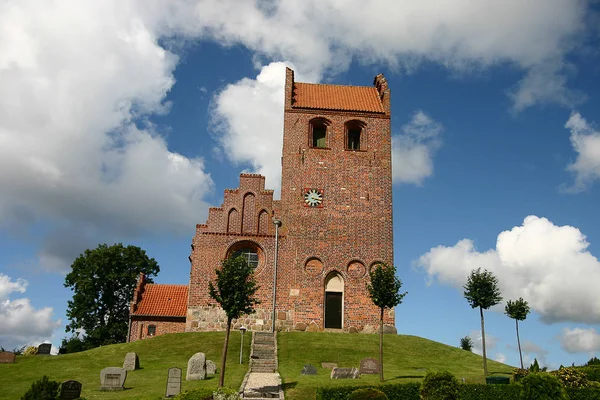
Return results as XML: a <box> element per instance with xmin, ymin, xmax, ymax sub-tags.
<box><xmin>133</xmin><ymin>283</ymin><xmax>188</xmax><ymax>317</ymax></box>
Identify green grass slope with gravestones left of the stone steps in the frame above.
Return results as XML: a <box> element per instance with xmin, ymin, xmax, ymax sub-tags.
<box><xmin>0</xmin><ymin>332</ymin><xmax>251</xmax><ymax>400</ymax></box>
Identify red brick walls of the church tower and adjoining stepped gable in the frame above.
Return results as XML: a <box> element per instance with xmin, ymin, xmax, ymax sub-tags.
<box><xmin>186</xmin><ymin>69</ymin><xmax>394</xmax><ymax>331</ymax></box>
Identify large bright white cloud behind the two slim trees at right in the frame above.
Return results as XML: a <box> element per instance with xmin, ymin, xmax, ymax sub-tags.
<box><xmin>416</xmin><ymin>216</ymin><xmax>600</xmax><ymax>323</ymax></box>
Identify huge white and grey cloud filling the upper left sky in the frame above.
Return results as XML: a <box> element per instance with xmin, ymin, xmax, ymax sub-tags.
<box><xmin>0</xmin><ymin>1</ymin><xmax>212</xmax><ymax>269</ymax></box>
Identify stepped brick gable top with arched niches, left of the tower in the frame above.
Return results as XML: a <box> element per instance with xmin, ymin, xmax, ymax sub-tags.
<box><xmin>196</xmin><ymin>173</ymin><xmax>279</xmax><ymax>236</ymax></box>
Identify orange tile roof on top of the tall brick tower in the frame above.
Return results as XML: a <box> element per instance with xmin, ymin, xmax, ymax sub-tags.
<box><xmin>292</xmin><ymin>83</ymin><xmax>385</xmax><ymax>113</ymax></box>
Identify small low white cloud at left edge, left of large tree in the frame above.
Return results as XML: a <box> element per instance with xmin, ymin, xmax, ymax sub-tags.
<box><xmin>0</xmin><ymin>273</ymin><xmax>61</xmax><ymax>349</ymax></box>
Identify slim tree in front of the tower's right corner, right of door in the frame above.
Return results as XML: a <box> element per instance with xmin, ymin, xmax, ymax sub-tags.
<box><xmin>367</xmin><ymin>264</ymin><xmax>408</xmax><ymax>382</ymax></box>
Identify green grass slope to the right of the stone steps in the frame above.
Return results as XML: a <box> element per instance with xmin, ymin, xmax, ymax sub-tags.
<box><xmin>278</xmin><ymin>332</ymin><xmax>513</xmax><ymax>400</ymax></box>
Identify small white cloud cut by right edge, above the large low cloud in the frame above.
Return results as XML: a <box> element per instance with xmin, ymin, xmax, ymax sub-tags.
<box><xmin>565</xmin><ymin>112</ymin><xmax>600</xmax><ymax>192</ymax></box>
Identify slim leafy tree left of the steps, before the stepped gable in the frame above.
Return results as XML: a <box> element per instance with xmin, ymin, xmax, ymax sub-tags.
<box><xmin>208</xmin><ymin>256</ymin><xmax>259</xmax><ymax>387</ymax></box>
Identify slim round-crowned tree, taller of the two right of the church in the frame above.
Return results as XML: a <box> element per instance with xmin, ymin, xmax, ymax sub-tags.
<box><xmin>463</xmin><ymin>268</ymin><xmax>502</xmax><ymax>376</ymax></box>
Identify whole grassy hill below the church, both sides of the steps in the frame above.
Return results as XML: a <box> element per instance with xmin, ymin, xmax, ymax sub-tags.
<box><xmin>0</xmin><ymin>332</ymin><xmax>512</xmax><ymax>400</ymax></box>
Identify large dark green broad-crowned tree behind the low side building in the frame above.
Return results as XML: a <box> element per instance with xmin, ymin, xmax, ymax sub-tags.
<box><xmin>64</xmin><ymin>243</ymin><xmax>160</xmax><ymax>348</ymax></box>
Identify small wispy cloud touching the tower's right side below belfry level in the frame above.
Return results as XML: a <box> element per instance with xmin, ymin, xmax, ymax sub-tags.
<box><xmin>392</xmin><ymin>110</ymin><xmax>444</xmax><ymax>185</ymax></box>
